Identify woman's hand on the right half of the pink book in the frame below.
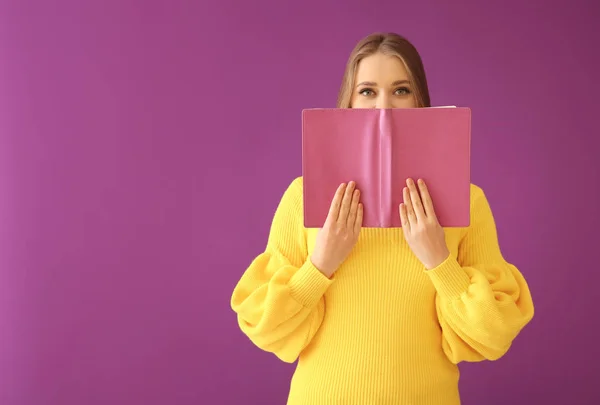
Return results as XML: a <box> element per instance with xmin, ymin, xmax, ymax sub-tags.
<box><xmin>399</xmin><ymin>179</ymin><xmax>450</xmax><ymax>270</ymax></box>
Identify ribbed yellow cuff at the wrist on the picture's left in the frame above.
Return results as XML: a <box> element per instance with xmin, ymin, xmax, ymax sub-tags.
<box><xmin>289</xmin><ymin>259</ymin><xmax>333</xmax><ymax>308</ymax></box>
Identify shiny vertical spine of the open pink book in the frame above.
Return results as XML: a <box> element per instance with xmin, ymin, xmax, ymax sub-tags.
<box><xmin>379</xmin><ymin>109</ymin><xmax>394</xmax><ymax>228</ymax></box>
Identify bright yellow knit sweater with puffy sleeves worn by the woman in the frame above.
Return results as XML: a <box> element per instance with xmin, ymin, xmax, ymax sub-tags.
<box><xmin>231</xmin><ymin>177</ymin><xmax>534</xmax><ymax>405</ymax></box>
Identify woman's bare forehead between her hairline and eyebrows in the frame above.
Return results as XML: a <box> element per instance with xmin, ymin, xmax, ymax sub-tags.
<box><xmin>356</xmin><ymin>53</ymin><xmax>408</xmax><ymax>85</ymax></box>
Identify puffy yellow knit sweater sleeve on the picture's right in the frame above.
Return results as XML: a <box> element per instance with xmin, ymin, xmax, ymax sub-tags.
<box><xmin>426</xmin><ymin>186</ymin><xmax>534</xmax><ymax>364</ymax></box>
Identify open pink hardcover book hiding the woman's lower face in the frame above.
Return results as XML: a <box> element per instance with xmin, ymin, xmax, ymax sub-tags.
<box><xmin>302</xmin><ymin>107</ymin><xmax>471</xmax><ymax>228</ymax></box>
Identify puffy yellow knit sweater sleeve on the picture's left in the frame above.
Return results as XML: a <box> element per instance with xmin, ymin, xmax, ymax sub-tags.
<box><xmin>231</xmin><ymin>178</ymin><xmax>333</xmax><ymax>363</ymax></box>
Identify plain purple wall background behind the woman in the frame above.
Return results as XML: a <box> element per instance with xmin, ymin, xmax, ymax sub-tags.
<box><xmin>0</xmin><ymin>0</ymin><xmax>600</xmax><ymax>405</ymax></box>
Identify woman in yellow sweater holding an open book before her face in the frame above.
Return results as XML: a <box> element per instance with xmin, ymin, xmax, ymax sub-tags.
<box><xmin>231</xmin><ymin>34</ymin><xmax>534</xmax><ymax>405</ymax></box>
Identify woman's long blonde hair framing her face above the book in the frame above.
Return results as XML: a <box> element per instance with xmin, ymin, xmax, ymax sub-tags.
<box><xmin>337</xmin><ymin>33</ymin><xmax>431</xmax><ymax>108</ymax></box>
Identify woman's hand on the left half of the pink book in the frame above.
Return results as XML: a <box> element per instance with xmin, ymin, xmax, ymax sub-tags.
<box><xmin>311</xmin><ymin>181</ymin><xmax>363</xmax><ymax>278</ymax></box>
